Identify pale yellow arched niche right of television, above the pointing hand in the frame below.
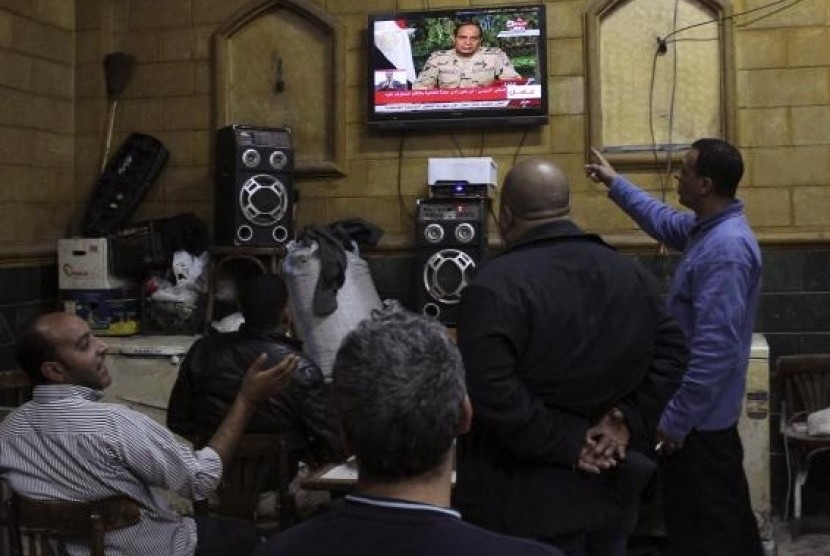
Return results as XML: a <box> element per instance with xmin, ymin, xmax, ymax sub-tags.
<box><xmin>584</xmin><ymin>0</ymin><xmax>735</xmax><ymax>170</ymax></box>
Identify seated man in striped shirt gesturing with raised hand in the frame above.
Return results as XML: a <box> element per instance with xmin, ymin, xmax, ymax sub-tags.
<box><xmin>0</xmin><ymin>313</ymin><xmax>297</xmax><ymax>556</ymax></box>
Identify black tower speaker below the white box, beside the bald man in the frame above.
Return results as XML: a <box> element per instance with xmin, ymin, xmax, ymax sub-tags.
<box><xmin>415</xmin><ymin>198</ymin><xmax>488</xmax><ymax>325</ymax></box>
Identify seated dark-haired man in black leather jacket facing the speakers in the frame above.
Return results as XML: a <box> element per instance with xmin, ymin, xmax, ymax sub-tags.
<box><xmin>167</xmin><ymin>274</ymin><xmax>343</xmax><ymax>465</ymax></box>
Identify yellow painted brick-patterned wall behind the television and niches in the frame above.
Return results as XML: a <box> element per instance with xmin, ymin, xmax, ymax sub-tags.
<box><xmin>0</xmin><ymin>0</ymin><xmax>830</xmax><ymax>257</ymax></box>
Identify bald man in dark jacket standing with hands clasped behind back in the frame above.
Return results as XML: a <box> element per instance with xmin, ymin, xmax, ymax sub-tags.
<box><xmin>454</xmin><ymin>159</ymin><xmax>686</xmax><ymax>556</ymax></box>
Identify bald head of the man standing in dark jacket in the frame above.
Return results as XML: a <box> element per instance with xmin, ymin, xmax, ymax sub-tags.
<box><xmin>501</xmin><ymin>158</ymin><xmax>570</xmax><ymax>221</ymax></box>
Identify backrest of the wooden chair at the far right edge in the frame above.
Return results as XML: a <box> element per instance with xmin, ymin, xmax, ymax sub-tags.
<box><xmin>776</xmin><ymin>353</ymin><xmax>830</xmax><ymax>419</ymax></box>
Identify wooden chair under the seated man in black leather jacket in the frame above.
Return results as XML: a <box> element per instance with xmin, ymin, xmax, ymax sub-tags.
<box><xmin>193</xmin><ymin>433</ymin><xmax>299</xmax><ymax>529</ymax></box>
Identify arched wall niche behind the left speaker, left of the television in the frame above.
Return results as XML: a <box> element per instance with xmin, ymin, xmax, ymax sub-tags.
<box><xmin>213</xmin><ymin>0</ymin><xmax>345</xmax><ymax>179</ymax></box>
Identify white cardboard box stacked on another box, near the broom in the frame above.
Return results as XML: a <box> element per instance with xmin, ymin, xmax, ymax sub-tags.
<box><xmin>58</xmin><ymin>237</ymin><xmax>133</xmax><ymax>290</ymax></box>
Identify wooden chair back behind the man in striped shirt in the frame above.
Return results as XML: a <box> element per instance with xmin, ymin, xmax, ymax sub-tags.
<box><xmin>4</xmin><ymin>494</ymin><xmax>141</xmax><ymax>556</ymax></box>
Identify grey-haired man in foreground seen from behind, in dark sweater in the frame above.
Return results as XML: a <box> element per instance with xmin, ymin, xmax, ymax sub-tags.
<box><xmin>258</xmin><ymin>311</ymin><xmax>561</xmax><ymax>556</ymax></box>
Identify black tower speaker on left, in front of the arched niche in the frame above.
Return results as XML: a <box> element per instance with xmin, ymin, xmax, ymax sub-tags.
<box><xmin>213</xmin><ymin>125</ymin><xmax>294</xmax><ymax>247</ymax></box>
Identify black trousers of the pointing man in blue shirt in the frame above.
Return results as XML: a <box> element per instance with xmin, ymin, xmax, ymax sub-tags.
<box><xmin>660</xmin><ymin>426</ymin><xmax>763</xmax><ymax>556</ymax></box>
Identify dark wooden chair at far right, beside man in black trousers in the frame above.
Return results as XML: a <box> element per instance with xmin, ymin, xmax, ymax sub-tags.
<box><xmin>776</xmin><ymin>353</ymin><xmax>830</xmax><ymax>538</ymax></box>
